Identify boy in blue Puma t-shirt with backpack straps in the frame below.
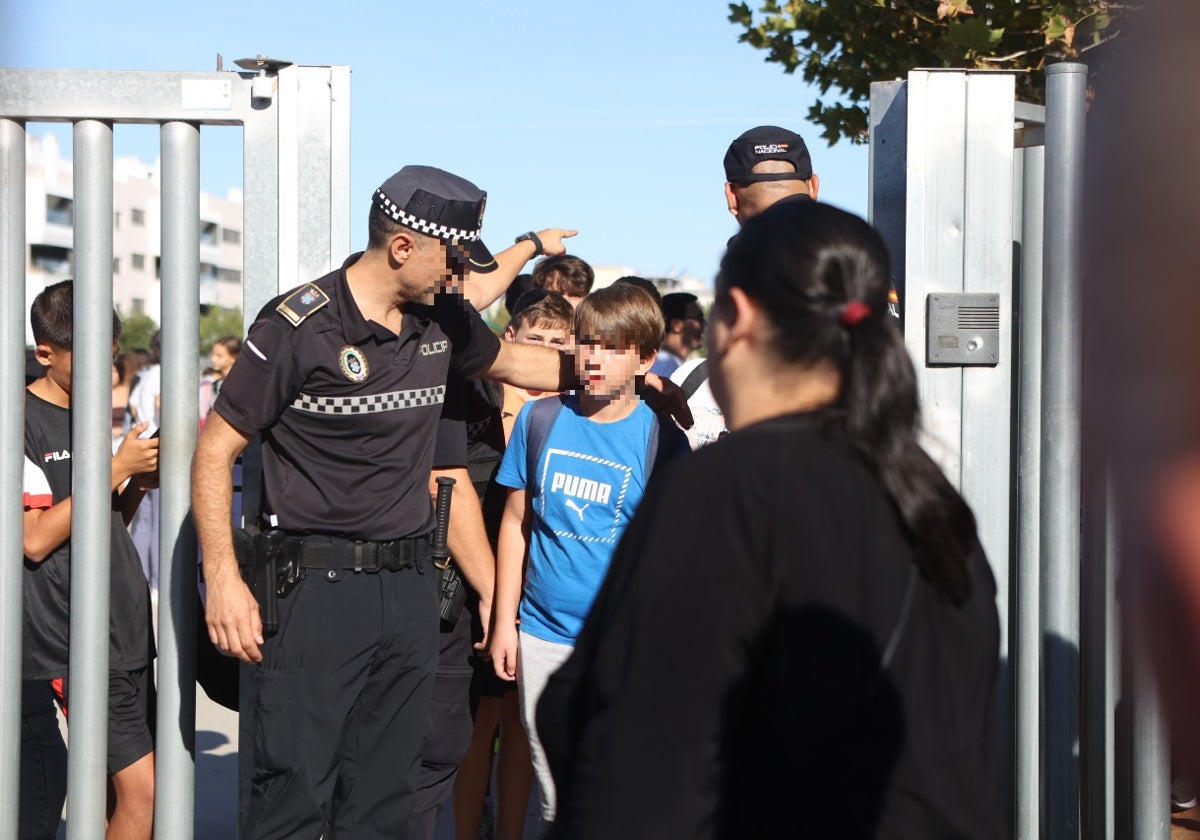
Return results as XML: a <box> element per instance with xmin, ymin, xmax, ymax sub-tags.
<box><xmin>490</xmin><ymin>284</ymin><xmax>688</xmax><ymax>823</ymax></box>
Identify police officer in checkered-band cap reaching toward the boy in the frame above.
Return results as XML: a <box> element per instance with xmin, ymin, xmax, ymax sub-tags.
<box><xmin>192</xmin><ymin>167</ymin><xmax>614</xmax><ymax>840</ymax></box>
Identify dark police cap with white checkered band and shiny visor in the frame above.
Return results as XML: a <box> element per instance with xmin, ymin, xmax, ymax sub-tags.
<box><xmin>371</xmin><ymin>166</ymin><xmax>497</xmax><ymax>274</ymax></box>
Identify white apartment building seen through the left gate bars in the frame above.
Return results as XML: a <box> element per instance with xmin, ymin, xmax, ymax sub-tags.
<box><xmin>25</xmin><ymin>133</ymin><xmax>242</xmax><ymax>343</ymax></box>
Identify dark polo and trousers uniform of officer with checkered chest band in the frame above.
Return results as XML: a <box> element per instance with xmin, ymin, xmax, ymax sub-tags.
<box><xmin>214</xmin><ymin>254</ymin><xmax>499</xmax><ymax>839</ymax></box>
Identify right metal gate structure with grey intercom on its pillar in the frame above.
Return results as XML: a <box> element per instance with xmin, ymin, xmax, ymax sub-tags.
<box><xmin>869</xmin><ymin>64</ymin><xmax>1170</xmax><ymax>840</ymax></box>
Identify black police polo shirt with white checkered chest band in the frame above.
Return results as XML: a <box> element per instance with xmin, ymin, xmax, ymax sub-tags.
<box><xmin>212</xmin><ymin>254</ymin><xmax>500</xmax><ymax>540</ymax></box>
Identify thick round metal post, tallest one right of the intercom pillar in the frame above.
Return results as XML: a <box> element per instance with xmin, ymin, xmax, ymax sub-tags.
<box><xmin>1039</xmin><ymin>64</ymin><xmax>1087</xmax><ymax>840</ymax></box>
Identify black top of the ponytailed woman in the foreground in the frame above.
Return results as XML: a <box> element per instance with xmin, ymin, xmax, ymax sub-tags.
<box><xmin>538</xmin><ymin>414</ymin><xmax>1004</xmax><ymax>840</ymax></box>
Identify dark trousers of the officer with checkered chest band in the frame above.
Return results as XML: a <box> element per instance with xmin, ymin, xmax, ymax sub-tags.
<box><xmin>241</xmin><ymin>559</ymin><xmax>438</xmax><ymax>840</ymax></box>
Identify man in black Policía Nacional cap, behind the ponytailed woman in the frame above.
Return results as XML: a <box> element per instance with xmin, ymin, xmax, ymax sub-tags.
<box><xmin>725</xmin><ymin>126</ymin><xmax>821</xmax><ymax>224</ymax></box>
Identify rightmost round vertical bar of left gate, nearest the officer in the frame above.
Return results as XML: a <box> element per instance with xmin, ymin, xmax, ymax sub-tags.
<box><xmin>155</xmin><ymin>122</ymin><xmax>200</xmax><ymax>840</ymax></box>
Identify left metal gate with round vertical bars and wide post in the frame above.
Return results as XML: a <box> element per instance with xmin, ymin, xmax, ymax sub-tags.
<box><xmin>0</xmin><ymin>63</ymin><xmax>350</xmax><ymax>840</ymax></box>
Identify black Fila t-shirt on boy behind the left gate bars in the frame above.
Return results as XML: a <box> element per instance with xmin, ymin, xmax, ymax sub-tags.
<box><xmin>22</xmin><ymin>391</ymin><xmax>154</xmax><ymax>679</ymax></box>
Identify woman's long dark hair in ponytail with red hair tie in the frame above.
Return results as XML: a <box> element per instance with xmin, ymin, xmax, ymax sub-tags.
<box><xmin>716</xmin><ymin>199</ymin><xmax>977</xmax><ymax>604</ymax></box>
